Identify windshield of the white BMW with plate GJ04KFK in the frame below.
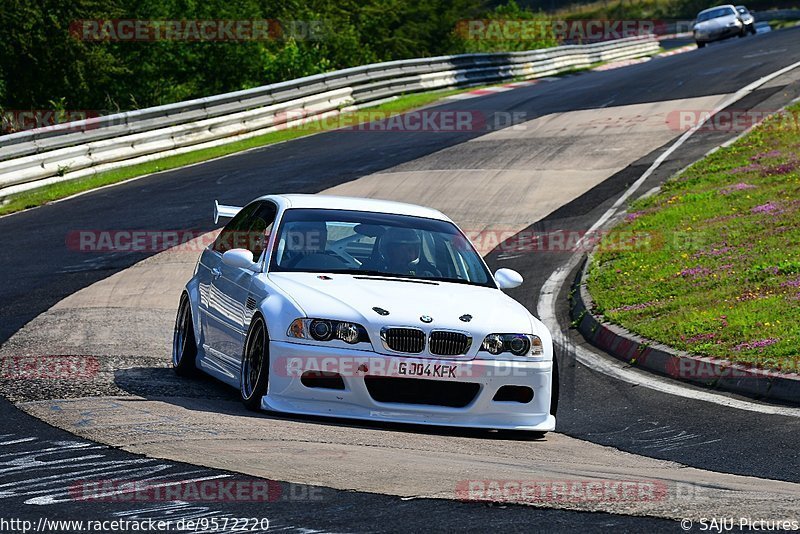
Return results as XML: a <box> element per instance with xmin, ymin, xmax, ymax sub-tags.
<box><xmin>270</xmin><ymin>209</ymin><xmax>495</xmax><ymax>287</ymax></box>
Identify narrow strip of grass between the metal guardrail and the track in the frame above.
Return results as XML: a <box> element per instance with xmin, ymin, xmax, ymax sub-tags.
<box><xmin>0</xmin><ymin>87</ymin><xmax>468</xmax><ymax>215</ymax></box>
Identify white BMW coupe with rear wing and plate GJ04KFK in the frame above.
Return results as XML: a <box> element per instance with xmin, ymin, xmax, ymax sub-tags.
<box><xmin>172</xmin><ymin>195</ymin><xmax>558</xmax><ymax>432</ymax></box>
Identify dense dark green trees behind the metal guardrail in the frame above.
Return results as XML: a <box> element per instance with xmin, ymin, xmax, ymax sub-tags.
<box><xmin>0</xmin><ymin>0</ymin><xmax>555</xmax><ymax>112</ymax></box>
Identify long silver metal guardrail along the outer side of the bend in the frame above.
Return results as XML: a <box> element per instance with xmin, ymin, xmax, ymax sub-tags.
<box><xmin>0</xmin><ymin>35</ymin><xmax>658</xmax><ymax>199</ymax></box>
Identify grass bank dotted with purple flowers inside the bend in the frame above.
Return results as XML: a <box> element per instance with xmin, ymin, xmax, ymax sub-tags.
<box><xmin>587</xmin><ymin>105</ymin><xmax>800</xmax><ymax>371</ymax></box>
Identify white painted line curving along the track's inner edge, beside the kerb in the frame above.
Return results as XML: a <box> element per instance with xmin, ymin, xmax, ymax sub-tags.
<box><xmin>537</xmin><ymin>61</ymin><xmax>800</xmax><ymax>417</ymax></box>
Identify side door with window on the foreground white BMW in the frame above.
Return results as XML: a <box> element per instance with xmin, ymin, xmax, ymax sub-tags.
<box><xmin>207</xmin><ymin>201</ymin><xmax>277</xmax><ymax>376</ymax></box>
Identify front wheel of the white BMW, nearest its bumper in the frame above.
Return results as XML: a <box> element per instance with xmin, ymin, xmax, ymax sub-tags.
<box><xmin>239</xmin><ymin>315</ymin><xmax>269</xmax><ymax>411</ymax></box>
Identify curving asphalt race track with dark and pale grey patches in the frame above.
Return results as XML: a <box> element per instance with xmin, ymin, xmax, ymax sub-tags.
<box><xmin>0</xmin><ymin>29</ymin><xmax>800</xmax><ymax>532</ymax></box>
